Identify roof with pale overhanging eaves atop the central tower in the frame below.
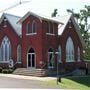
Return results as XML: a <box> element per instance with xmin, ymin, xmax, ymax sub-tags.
<box><xmin>17</xmin><ymin>11</ymin><xmax>63</xmax><ymax>24</ymax></box>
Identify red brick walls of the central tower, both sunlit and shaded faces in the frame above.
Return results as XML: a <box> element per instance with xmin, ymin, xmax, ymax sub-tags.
<box><xmin>22</xmin><ymin>15</ymin><xmax>58</xmax><ymax>68</ymax></box>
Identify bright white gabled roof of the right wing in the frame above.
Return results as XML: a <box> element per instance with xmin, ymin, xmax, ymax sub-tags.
<box><xmin>55</xmin><ymin>14</ymin><xmax>85</xmax><ymax>47</ymax></box>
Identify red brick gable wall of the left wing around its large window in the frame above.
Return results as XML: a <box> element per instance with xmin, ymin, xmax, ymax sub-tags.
<box><xmin>0</xmin><ymin>21</ymin><xmax>21</xmax><ymax>66</ymax></box>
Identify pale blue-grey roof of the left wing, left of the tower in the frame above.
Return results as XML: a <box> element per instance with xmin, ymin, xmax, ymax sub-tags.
<box><xmin>0</xmin><ymin>13</ymin><xmax>22</xmax><ymax>35</ymax></box>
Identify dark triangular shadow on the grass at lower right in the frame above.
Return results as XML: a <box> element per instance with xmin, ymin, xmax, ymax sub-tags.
<box><xmin>66</xmin><ymin>76</ymin><xmax>90</xmax><ymax>87</ymax></box>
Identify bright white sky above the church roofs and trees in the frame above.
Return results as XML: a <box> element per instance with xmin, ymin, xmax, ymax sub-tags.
<box><xmin>0</xmin><ymin>0</ymin><xmax>90</xmax><ymax>16</ymax></box>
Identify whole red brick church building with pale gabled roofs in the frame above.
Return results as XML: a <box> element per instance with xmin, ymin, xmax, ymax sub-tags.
<box><xmin>0</xmin><ymin>12</ymin><xmax>84</xmax><ymax>75</ymax></box>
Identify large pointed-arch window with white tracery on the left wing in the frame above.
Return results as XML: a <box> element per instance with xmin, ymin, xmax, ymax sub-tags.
<box><xmin>1</xmin><ymin>37</ymin><xmax>11</xmax><ymax>61</ymax></box>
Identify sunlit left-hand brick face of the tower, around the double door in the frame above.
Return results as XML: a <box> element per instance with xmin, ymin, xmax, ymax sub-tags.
<box><xmin>22</xmin><ymin>15</ymin><xmax>42</xmax><ymax>68</ymax></box>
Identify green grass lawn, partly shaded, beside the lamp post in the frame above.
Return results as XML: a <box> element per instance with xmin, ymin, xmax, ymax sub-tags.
<box><xmin>45</xmin><ymin>76</ymin><xmax>90</xmax><ymax>90</ymax></box>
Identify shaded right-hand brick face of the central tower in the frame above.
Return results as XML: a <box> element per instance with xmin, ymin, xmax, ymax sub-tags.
<box><xmin>42</xmin><ymin>21</ymin><xmax>58</xmax><ymax>68</ymax></box>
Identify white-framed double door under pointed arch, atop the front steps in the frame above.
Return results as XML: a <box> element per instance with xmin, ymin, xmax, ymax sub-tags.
<box><xmin>27</xmin><ymin>48</ymin><xmax>36</xmax><ymax>68</ymax></box>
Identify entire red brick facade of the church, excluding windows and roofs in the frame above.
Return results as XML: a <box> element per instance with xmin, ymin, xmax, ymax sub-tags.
<box><xmin>0</xmin><ymin>12</ymin><xmax>83</xmax><ymax>71</ymax></box>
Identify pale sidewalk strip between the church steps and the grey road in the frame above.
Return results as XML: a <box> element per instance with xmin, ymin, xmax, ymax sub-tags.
<box><xmin>0</xmin><ymin>74</ymin><xmax>56</xmax><ymax>81</ymax></box>
